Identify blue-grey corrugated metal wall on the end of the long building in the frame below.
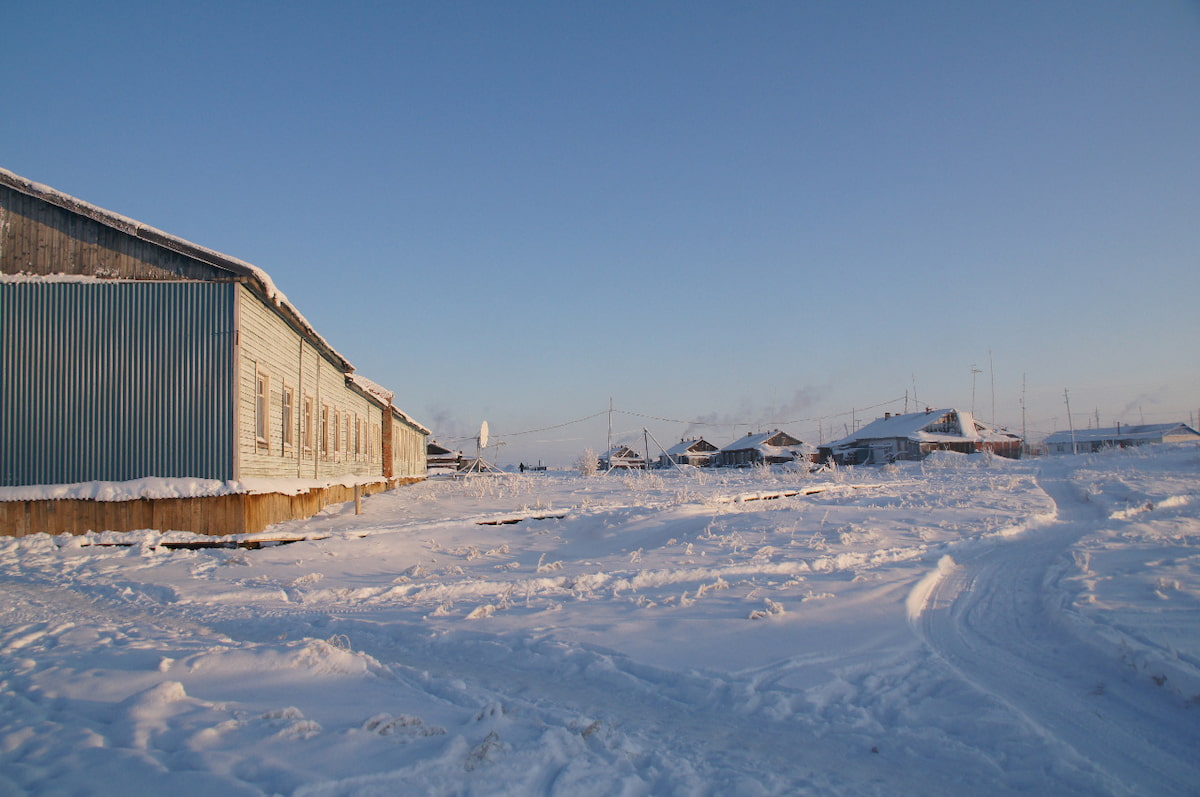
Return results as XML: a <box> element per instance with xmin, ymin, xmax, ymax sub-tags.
<box><xmin>0</xmin><ymin>282</ymin><xmax>236</xmax><ymax>486</ymax></box>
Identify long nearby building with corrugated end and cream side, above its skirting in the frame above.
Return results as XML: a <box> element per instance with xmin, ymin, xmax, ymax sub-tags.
<box><xmin>0</xmin><ymin>169</ymin><xmax>430</xmax><ymax>533</ymax></box>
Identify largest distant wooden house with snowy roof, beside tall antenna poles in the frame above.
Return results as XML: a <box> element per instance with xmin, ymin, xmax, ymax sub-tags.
<box><xmin>820</xmin><ymin>408</ymin><xmax>1021</xmax><ymax>465</ymax></box>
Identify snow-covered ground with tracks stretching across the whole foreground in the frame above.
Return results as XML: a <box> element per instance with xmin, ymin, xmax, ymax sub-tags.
<box><xmin>0</xmin><ymin>447</ymin><xmax>1200</xmax><ymax>797</ymax></box>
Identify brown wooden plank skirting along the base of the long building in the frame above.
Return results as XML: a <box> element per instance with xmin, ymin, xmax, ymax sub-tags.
<box><xmin>0</xmin><ymin>478</ymin><xmax>421</xmax><ymax>537</ymax></box>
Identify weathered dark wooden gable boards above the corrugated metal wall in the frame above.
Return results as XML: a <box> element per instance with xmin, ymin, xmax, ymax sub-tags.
<box><xmin>0</xmin><ymin>185</ymin><xmax>240</xmax><ymax>281</ymax></box>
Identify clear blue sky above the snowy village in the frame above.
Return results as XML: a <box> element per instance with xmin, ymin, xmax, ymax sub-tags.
<box><xmin>0</xmin><ymin>0</ymin><xmax>1200</xmax><ymax>463</ymax></box>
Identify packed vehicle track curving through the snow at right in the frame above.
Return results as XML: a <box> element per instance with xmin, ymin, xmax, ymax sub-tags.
<box><xmin>913</xmin><ymin>477</ymin><xmax>1200</xmax><ymax>795</ymax></box>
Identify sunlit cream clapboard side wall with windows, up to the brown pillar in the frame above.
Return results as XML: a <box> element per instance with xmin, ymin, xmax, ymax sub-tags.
<box><xmin>236</xmin><ymin>287</ymin><xmax>390</xmax><ymax>479</ymax></box>
